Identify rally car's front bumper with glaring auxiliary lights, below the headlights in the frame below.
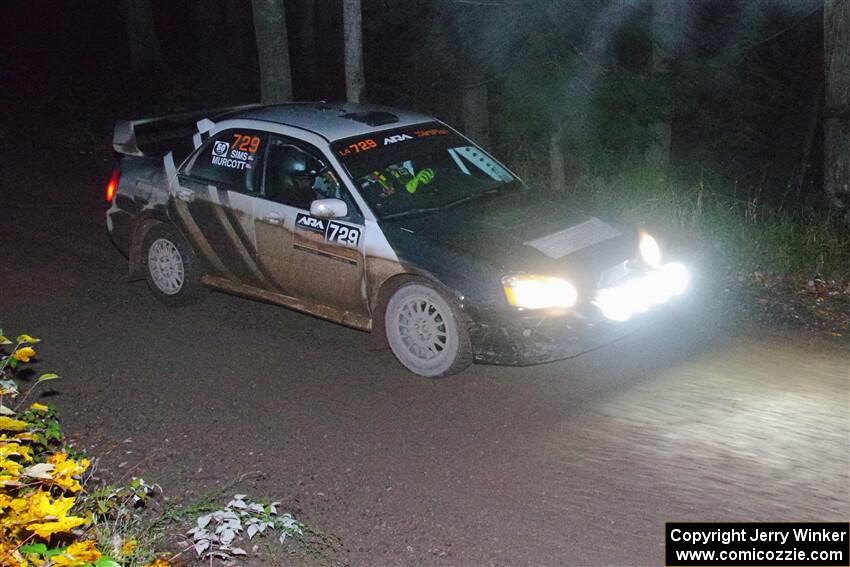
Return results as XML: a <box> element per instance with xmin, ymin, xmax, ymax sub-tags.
<box><xmin>467</xmin><ymin>264</ymin><xmax>687</xmax><ymax>366</ymax></box>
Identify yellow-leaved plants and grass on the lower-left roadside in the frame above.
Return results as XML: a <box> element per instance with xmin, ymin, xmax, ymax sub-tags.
<box><xmin>0</xmin><ymin>330</ymin><xmax>346</xmax><ymax>567</ymax></box>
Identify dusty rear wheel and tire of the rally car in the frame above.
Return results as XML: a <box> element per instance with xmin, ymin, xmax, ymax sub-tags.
<box><xmin>142</xmin><ymin>224</ymin><xmax>206</xmax><ymax>307</ymax></box>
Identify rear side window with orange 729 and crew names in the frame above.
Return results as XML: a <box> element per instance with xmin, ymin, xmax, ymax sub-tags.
<box><xmin>183</xmin><ymin>129</ymin><xmax>265</xmax><ymax>193</ymax></box>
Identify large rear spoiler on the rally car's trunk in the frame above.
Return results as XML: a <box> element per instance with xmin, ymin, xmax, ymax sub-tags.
<box><xmin>112</xmin><ymin>104</ymin><xmax>263</xmax><ymax>156</ymax></box>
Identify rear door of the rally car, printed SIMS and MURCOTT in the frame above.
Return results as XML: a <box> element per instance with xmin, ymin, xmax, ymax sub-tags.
<box><xmin>172</xmin><ymin>129</ymin><xmax>269</xmax><ymax>287</ymax></box>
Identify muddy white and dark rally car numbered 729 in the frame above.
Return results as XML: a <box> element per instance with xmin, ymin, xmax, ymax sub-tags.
<box><xmin>106</xmin><ymin>103</ymin><xmax>688</xmax><ymax>377</ymax></box>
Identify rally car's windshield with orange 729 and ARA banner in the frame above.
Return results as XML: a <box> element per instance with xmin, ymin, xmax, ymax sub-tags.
<box><xmin>331</xmin><ymin>122</ymin><xmax>517</xmax><ymax>219</ymax></box>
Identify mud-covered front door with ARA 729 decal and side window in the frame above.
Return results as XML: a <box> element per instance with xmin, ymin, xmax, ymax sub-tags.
<box><xmin>255</xmin><ymin>136</ymin><xmax>368</xmax><ymax>322</ymax></box>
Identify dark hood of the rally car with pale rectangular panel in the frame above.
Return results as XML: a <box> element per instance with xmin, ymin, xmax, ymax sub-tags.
<box><xmin>381</xmin><ymin>191</ymin><xmax>637</xmax><ymax>292</ymax></box>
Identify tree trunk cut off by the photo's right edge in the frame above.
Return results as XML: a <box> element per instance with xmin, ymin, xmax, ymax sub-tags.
<box><xmin>823</xmin><ymin>0</ymin><xmax>850</xmax><ymax>216</ymax></box>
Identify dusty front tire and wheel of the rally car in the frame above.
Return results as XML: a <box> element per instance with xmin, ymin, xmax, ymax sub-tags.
<box><xmin>384</xmin><ymin>283</ymin><xmax>472</xmax><ymax>378</ymax></box>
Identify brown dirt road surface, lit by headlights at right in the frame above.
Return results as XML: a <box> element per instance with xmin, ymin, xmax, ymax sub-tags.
<box><xmin>0</xmin><ymin>149</ymin><xmax>850</xmax><ymax>566</ymax></box>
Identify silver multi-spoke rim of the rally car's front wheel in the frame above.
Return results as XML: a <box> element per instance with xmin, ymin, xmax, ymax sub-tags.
<box><xmin>396</xmin><ymin>296</ymin><xmax>449</xmax><ymax>363</ymax></box>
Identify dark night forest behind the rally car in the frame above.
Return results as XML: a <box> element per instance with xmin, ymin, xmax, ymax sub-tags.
<box><xmin>0</xmin><ymin>0</ymin><xmax>850</xmax><ymax>276</ymax></box>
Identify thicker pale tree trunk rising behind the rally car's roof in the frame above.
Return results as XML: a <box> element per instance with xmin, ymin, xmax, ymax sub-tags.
<box><xmin>252</xmin><ymin>0</ymin><xmax>292</xmax><ymax>104</ymax></box>
